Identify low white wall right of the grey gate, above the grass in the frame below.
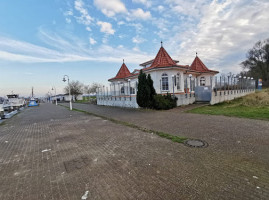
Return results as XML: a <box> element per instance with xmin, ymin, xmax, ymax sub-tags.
<box><xmin>210</xmin><ymin>89</ymin><xmax>255</xmax><ymax>105</ymax></box>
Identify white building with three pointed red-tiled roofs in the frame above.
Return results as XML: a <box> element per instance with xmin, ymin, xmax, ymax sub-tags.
<box><xmin>97</xmin><ymin>47</ymin><xmax>218</xmax><ymax>107</ymax></box>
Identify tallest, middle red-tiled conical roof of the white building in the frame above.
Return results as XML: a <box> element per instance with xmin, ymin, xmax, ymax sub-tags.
<box><xmin>149</xmin><ymin>47</ymin><xmax>176</xmax><ymax>68</ymax></box>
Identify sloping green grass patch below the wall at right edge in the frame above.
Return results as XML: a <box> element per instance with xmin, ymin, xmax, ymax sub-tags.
<box><xmin>187</xmin><ymin>89</ymin><xmax>269</xmax><ymax>120</ymax></box>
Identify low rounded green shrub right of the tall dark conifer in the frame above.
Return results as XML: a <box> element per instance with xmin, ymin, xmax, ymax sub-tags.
<box><xmin>154</xmin><ymin>94</ymin><xmax>177</xmax><ymax>110</ymax></box>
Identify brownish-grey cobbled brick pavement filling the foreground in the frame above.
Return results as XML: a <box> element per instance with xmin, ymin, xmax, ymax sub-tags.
<box><xmin>0</xmin><ymin>104</ymin><xmax>269</xmax><ymax>200</ymax></box>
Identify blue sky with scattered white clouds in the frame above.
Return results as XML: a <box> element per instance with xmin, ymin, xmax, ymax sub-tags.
<box><xmin>0</xmin><ymin>0</ymin><xmax>269</xmax><ymax>96</ymax></box>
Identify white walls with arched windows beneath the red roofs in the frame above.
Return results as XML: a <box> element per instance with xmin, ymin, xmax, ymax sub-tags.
<box><xmin>108</xmin><ymin>69</ymin><xmax>215</xmax><ymax>96</ymax></box>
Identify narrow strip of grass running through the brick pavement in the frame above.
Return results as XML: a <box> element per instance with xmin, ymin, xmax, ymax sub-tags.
<box><xmin>59</xmin><ymin>104</ymin><xmax>188</xmax><ymax>143</ymax></box>
